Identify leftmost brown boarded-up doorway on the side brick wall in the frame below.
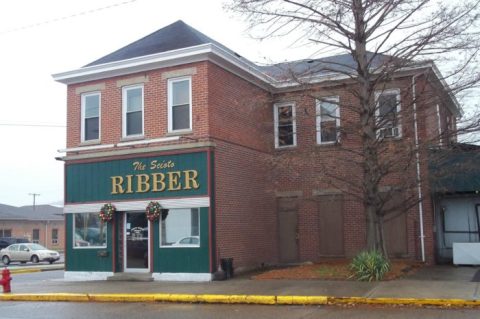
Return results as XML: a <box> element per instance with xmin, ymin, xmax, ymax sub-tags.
<box><xmin>277</xmin><ymin>198</ymin><xmax>298</xmax><ymax>263</ymax></box>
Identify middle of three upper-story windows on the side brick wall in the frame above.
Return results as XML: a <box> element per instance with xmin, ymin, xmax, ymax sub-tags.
<box><xmin>317</xmin><ymin>96</ymin><xmax>340</xmax><ymax>144</ymax></box>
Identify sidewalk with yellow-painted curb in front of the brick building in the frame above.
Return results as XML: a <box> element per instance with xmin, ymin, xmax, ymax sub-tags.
<box><xmin>0</xmin><ymin>266</ymin><xmax>480</xmax><ymax>307</ymax></box>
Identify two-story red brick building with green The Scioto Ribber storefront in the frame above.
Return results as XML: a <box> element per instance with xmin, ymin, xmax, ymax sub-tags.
<box><xmin>54</xmin><ymin>21</ymin><xmax>460</xmax><ymax>280</ymax></box>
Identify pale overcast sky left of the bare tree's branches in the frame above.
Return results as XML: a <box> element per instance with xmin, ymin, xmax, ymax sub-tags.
<box><xmin>0</xmin><ymin>0</ymin><xmax>312</xmax><ymax>206</ymax></box>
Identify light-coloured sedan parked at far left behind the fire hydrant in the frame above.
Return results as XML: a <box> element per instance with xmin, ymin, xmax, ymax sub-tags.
<box><xmin>0</xmin><ymin>243</ymin><xmax>60</xmax><ymax>265</ymax></box>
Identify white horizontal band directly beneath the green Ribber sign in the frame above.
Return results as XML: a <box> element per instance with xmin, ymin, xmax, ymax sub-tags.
<box><xmin>63</xmin><ymin>194</ymin><xmax>210</xmax><ymax>214</ymax></box>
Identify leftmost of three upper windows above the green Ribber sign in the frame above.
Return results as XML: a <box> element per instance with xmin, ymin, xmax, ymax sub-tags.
<box><xmin>81</xmin><ymin>92</ymin><xmax>100</xmax><ymax>142</ymax></box>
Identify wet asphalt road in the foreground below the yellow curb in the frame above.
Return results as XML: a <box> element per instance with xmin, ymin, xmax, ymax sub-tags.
<box><xmin>0</xmin><ymin>302</ymin><xmax>479</xmax><ymax>319</ymax></box>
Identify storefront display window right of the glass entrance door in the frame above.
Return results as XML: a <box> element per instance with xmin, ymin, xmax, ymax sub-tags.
<box><xmin>160</xmin><ymin>208</ymin><xmax>200</xmax><ymax>248</ymax></box>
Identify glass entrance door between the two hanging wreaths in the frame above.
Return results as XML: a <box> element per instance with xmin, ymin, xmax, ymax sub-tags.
<box><xmin>124</xmin><ymin>212</ymin><xmax>149</xmax><ymax>272</ymax></box>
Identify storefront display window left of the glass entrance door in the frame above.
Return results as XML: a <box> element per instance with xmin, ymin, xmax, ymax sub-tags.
<box><xmin>73</xmin><ymin>213</ymin><xmax>107</xmax><ymax>248</ymax></box>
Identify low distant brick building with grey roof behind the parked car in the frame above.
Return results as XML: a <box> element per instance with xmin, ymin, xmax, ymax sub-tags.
<box><xmin>0</xmin><ymin>204</ymin><xmax>65</xmax><ymax>250</ymax></box>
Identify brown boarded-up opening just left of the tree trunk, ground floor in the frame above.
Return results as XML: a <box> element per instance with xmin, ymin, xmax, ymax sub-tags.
<box><xmin>318</xmin><ymin>194</ymin><xmax>344</xmax><ymax>256</ymax></box>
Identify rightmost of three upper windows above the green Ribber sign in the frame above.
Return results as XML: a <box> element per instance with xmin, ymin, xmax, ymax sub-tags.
<box><xmin>168</xmin><ymin>77</ymin><xmax>192</xmax><ymax>132</ymax></box>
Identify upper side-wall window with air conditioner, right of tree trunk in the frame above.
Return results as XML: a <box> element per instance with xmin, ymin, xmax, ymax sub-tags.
<box><xmin>375</xmin><ymin>89</ymin><xmax>402</xmax><ymax>138</ymax></box>
